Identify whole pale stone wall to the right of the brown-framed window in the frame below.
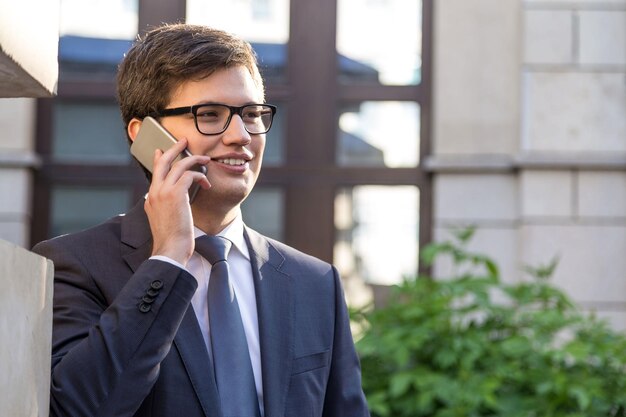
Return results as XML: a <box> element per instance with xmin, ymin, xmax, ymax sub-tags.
<box><xmin>427</xmin><ymin>0</ymin><xmax>626</xmax><ymax>328</ymax></box>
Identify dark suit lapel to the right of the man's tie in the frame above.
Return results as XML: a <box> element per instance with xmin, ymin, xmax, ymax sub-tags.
<box><xmin>245</xmin><ymin>228</ymin><xmax>294</xmax><ymax>416</ymax></box>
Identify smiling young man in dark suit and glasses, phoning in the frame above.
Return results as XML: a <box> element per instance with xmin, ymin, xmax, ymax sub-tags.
<box><xmin>34</xmin><ymin>25</ymin><xmax>369</xmax><ymax>417</ymax></box>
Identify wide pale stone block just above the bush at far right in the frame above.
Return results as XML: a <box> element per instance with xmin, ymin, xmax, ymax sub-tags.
<box><xmin>520</xmin><ymin>224</ymin><xmax>626</xmax><ymax>304</ymax></box>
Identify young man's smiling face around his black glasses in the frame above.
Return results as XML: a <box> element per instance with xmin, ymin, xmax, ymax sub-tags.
<box><xmin>161</xmin><ymin>67</ymin><xmax>265</xmax><ymax>207</ymax></box>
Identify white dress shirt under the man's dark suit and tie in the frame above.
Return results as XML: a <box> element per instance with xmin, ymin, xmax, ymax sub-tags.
<box><xmin>152</xmin><ymin>214</ymin><xmax>264</xmax><ymax>416</ymax></box>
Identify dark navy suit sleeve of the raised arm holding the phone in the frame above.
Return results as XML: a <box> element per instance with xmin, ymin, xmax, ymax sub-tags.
<box><xmin>33</xmin><ymin>239</ymin><xmax>197</xmax><ymax>417</ymax></box>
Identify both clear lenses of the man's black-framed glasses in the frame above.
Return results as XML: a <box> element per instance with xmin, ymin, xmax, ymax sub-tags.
<box><xmin>196</xmin><ymin>104</ymin><xmax>272</xmax><ymax>135</ymax></box>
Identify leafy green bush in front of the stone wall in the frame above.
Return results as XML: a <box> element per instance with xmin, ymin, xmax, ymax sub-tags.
<box><xmin>353</xmin><ymin>229</ymin><xmax>626</xmax><ymax>417</ymax></box>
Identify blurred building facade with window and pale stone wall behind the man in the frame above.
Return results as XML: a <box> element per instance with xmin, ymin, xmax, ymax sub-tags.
<box><xmin>0</xmin><ymin>0</ymin><xmax>626</xmax><ymax>329</ymax></box>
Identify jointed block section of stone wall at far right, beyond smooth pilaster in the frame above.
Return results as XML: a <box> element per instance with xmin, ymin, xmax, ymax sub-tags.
<box><xmin>519</xmin><ymin>0</ymin><xmax>626</xmax><ymax>328</ymax></box>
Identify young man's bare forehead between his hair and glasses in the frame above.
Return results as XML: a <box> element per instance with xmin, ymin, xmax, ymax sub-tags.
<box><xmin>168</xmin><ymin>66</ymin><xmax>263</xmax><ymax>107</ymax></box>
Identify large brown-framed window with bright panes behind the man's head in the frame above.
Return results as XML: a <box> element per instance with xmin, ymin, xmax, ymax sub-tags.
<box><xmin>32</xmin><ymin>0</ymin><xmax>432</xmax><ymax>290</ymax></box>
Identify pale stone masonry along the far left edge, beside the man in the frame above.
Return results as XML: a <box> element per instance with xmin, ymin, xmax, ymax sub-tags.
<box><xmin>0</xmin><ymin>0</ymin><xmax>60</xmax><ymax>417</ymax></box>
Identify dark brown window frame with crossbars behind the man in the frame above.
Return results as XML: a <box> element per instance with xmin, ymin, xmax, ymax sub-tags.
<box><xmin>31</xmin><ymin>0</ymin><xmax>433</xmax><ymax>276</ymax></box>
